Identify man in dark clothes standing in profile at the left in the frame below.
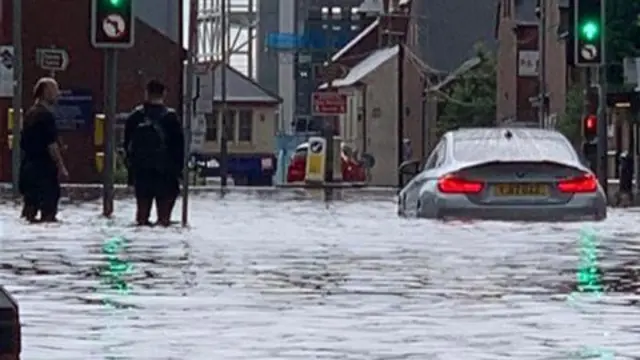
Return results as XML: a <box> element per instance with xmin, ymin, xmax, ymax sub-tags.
<box><xmin>19</xmin><ymin>77</ymin><xmax>69</xmax><ymax>222</ymax></box>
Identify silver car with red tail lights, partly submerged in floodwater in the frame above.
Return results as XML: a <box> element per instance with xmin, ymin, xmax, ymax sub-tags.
<box><xmin>398</xmin><ymin>128</ymin><xmax>607</xmax><ymax>221</ymax></box>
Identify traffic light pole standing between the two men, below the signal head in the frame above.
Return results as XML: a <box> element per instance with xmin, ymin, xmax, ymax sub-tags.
<box><xmin>102</xmin><ymin>49</ymin><xmax>118</xmax><ymax>217</ymax></box>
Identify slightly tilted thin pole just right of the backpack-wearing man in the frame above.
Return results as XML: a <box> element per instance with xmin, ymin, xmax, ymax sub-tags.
<box><xmin>182</xmin><ymin>0</ymin><xmax>198</xmax><ymax>227</ymax></box>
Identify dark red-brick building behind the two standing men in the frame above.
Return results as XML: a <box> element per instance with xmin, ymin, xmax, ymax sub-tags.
<box><xmin>0</xmin><ymin>0</ymin><xmax>184</xmax><ymax>182</ymax></box>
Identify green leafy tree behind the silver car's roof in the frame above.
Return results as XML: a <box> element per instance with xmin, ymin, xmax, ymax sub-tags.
<box><xmin>437</xmin><ymin>45</ymin><xmax>497</xmax><ymax>136</ymax></box>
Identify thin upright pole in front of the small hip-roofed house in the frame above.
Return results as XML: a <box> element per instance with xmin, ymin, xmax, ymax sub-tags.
<box><xmin>220</xmin><ymin>0</ymin><xmax>229</xmax><ymax>191</ymax></box>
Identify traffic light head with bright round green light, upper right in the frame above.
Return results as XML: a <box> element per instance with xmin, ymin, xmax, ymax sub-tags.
<box><xmin>574</xmin><ymin>0</ymin><xmax>605</xmax><ymax>66</ymax></box>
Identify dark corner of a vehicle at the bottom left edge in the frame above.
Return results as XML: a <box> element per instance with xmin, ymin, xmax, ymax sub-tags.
<box><xmin>0</xmin><ymin>286</ymin><xmax>22</xmax><ymax>360</ymax></box>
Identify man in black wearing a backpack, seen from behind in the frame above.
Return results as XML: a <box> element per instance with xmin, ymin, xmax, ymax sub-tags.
<box><xmin>123</xmin><ymin>80</ymin><xmax>184</xmax><ymax>226</ymax></box>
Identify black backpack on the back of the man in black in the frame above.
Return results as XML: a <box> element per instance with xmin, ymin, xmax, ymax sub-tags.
<box><xmin>129</xmin><ymin>112</ymin><xmax>170</xmax><ymax>174</ymax></box>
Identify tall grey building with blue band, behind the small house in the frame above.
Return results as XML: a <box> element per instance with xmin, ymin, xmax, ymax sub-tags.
<box><xmin>257</xmin><ymin>0</ymin><xmax>367</xmax><ymax>132</ymax></box>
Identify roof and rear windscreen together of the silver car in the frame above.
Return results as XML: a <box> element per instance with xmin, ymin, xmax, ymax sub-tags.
<box><xmin>445</xmin><ymin>127</ymin><xmax>578</xmax><ymax>162</ymax></box>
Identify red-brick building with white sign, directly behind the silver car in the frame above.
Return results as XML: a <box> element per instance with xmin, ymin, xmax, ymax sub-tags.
<box><xmin>496</xmin><ymin>0</ymin><xmax>572</xmax><ymax>122</ymax></box>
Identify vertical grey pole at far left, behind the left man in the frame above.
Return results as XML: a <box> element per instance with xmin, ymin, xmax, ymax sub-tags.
<box><xmin>11</xmin><ymin>0</ymin><xmax>23</xmax><ymax>198</ymax></box>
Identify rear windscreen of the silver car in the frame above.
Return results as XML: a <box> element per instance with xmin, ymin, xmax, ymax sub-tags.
<box><xmin>453</xmin><ymin>137</ymin><xmax>578</xmax><ymax>162</ymax></box>
